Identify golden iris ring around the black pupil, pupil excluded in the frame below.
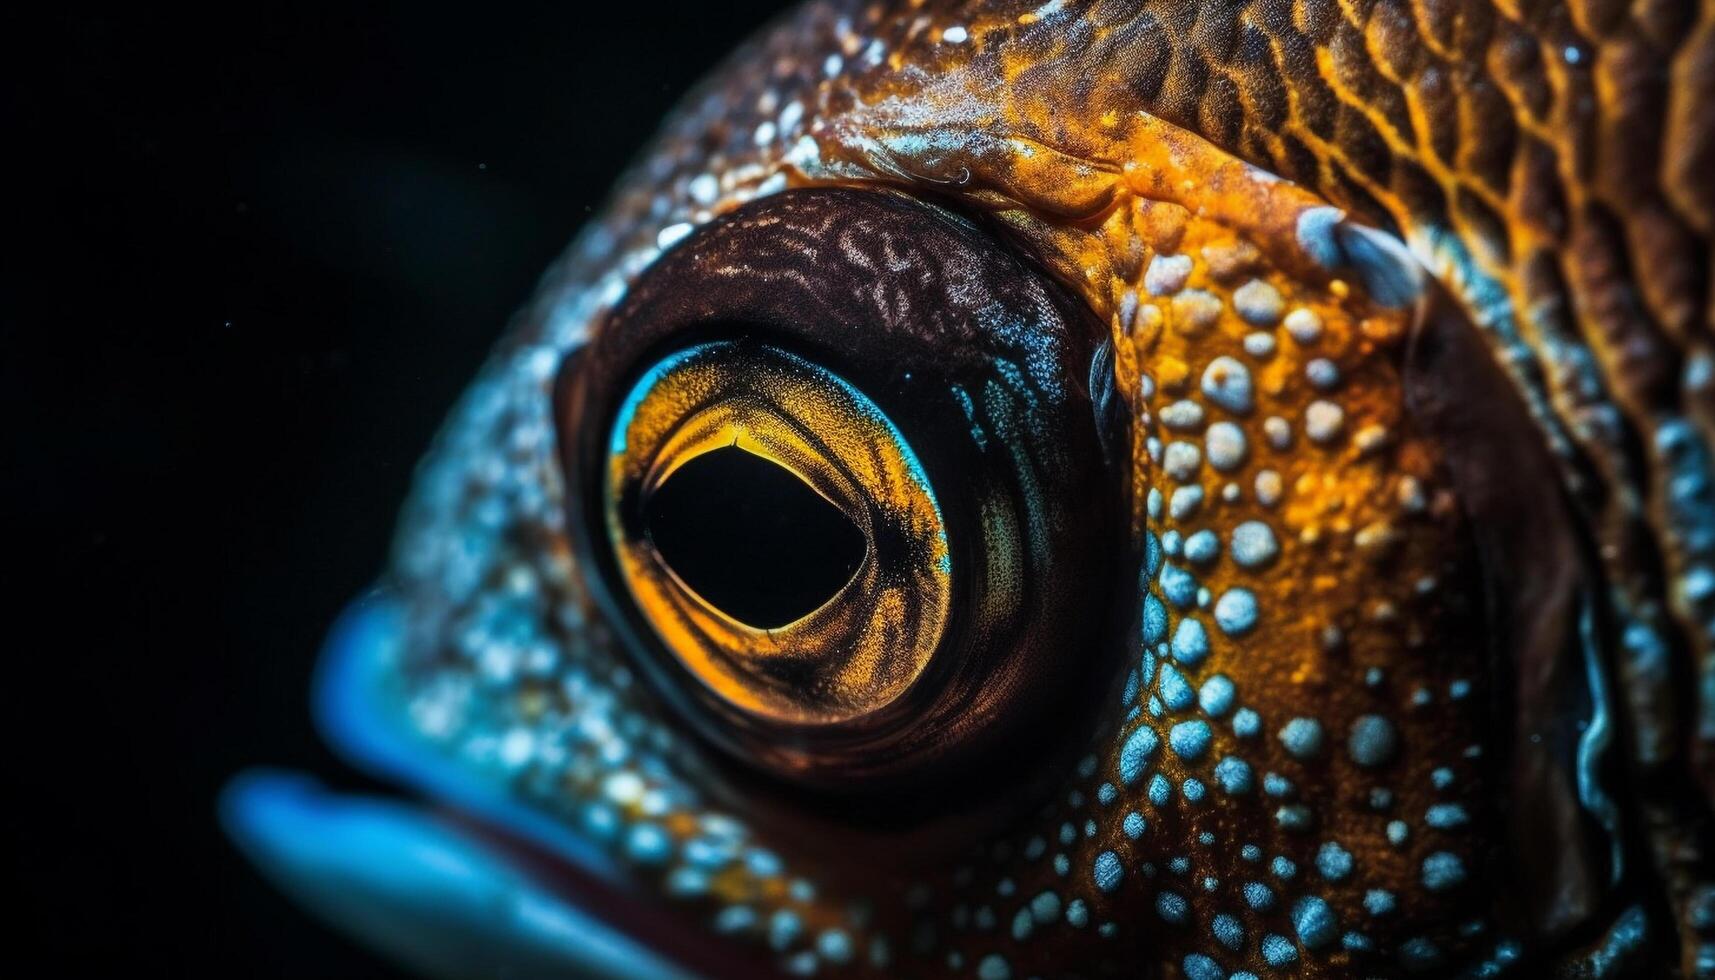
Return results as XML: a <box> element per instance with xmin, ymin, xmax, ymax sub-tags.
<box><xmin>604</xmin><ymin>340</ymin><xmax>952</xmax><ymax>724</ymax></box>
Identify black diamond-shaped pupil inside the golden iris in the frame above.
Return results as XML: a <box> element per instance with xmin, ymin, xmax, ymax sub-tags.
<box><xmin>643</xmin><ymin>448</ymin><xmax>864</xmax><ymax>630</ymax></box>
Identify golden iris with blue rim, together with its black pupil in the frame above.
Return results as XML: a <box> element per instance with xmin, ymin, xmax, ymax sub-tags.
<box><xmin>604</xmin><ymin>342</ymin><xmax>952</xmax><ymax>724</ymax></box>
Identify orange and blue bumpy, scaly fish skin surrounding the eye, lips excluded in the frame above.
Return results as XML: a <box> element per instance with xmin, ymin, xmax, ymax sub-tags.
<box><xmin>260</xmin><ymin>0</ymin><xmax>1715</xmax><ymax>980</ymax></box>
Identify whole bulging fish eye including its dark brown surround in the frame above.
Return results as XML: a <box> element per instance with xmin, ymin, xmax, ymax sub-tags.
<box><xmin>559</xmin><ymin>189</ymin><xmax>1125</xmax><ymax>788</ymax></box>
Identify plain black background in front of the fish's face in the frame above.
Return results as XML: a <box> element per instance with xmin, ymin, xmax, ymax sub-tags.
<box><xmin>11</xmin><ymin>2</ymin><xmax>779</xmax><ymax>977</ymax></box>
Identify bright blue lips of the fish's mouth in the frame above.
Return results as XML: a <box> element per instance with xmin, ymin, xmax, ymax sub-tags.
<box><xmin>220</xmin><ymin>590</ymin><xmax>775</xmax><ymax>978</ymax></box>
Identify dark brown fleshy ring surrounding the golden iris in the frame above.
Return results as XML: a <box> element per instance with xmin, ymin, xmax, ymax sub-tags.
<box><xmin>554</xmin><ymin>187</ymin><xmax>1139</xmax><ymax>796</ymax></box>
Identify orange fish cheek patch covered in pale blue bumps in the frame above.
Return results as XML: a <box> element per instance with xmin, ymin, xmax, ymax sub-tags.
<box><xmin>987</xmin><ymin>203</ymin><xmax>1509</xmax><ymax>971</ymax></box>
